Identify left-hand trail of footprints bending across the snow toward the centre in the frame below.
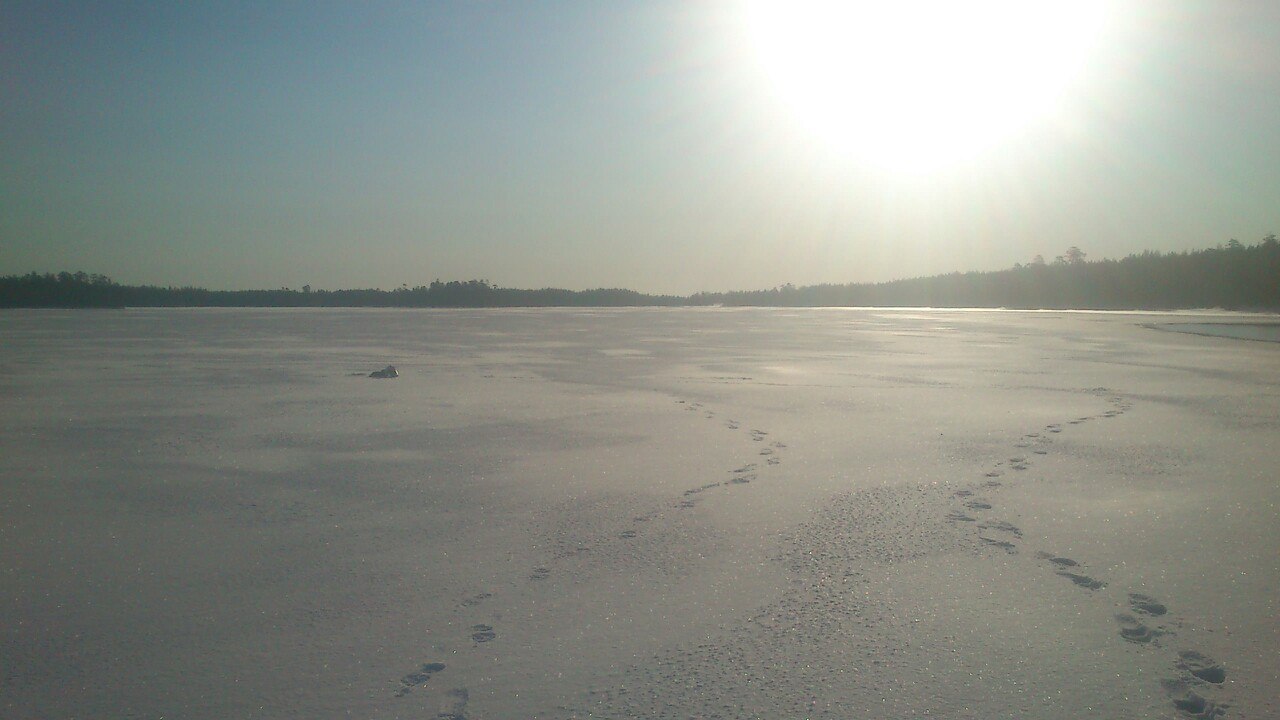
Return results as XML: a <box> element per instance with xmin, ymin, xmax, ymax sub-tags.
<box><xmin>394</xmin><ymin>392</ymin><xmax>787</xmax><ymax>707</ymax></box>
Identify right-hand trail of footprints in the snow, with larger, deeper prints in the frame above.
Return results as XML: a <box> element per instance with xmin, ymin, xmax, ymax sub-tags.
<box><xmin>947</xmin><ymin>388</ymin><xmax>1228</xmax><ymax>720</ymax></box>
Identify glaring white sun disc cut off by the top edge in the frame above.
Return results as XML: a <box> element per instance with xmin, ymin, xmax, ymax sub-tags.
<box><xmin>746</xmin><ymin>0</ymin><xmax>1108</xmax><ymax>172</ymax></box>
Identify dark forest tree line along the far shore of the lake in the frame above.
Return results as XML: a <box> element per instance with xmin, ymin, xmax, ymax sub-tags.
<box><xmin>0</xmin><ymin>234</ymin><xmax>1280</xmax><ymax>310</ymax></box>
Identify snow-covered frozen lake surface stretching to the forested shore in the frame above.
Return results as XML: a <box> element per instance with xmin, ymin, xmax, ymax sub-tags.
<box><xmin>0</xmin><ymin>309</ymin><xmax>1280</xmax><ymax>719</ymax></box>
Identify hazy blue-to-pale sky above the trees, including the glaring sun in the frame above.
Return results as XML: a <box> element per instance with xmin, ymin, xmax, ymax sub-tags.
<box><xmin>0</xmin><ymin>0</ymin><xmax>1280</xmax><ymax>293</ymax></box>
